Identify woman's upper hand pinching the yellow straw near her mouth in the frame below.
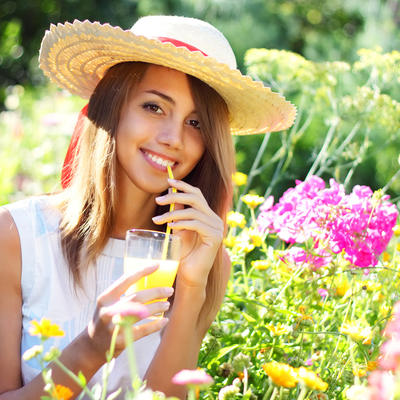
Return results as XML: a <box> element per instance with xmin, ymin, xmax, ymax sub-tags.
<box><xmin>153</xmin><ymin>179</ymin><xmax>224</xmax><ymax>287</ymax></box>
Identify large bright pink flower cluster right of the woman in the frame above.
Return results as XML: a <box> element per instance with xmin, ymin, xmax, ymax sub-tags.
<box><xmin>257</xmin><ymin>176</ymin><xmax>398</xmax><ymax>268</ymax></box>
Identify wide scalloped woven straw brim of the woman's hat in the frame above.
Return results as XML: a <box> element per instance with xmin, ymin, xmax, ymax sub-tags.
<box><xmin>39</xmin><ymin>20</ymin><xmax>296</xmax><ymax>135</ymax></box>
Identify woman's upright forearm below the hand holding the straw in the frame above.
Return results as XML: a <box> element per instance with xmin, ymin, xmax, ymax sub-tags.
<box><xmin>145</xmin><ymin>284</ymin><xmax>206</xmax><ymax>399</ymax></box>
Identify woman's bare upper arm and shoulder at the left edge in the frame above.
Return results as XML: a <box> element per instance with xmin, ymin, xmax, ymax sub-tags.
<box><xmin>0</xmin><ymin>207</ymin><xmax>22</xmax><ymax>393</ymax></box>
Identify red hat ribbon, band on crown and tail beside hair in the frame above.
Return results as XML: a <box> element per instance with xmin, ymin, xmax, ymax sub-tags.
<box><xmin>61</xmin><ymin>37</ymin><xmax>208</xmax><ymax>189</ymax></box>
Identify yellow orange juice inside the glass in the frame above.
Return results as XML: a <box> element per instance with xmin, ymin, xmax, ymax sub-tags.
<box><xmin>124</xmin><ymin>257</ymin><xmax>179</xmax><ymax>298</ymax></box>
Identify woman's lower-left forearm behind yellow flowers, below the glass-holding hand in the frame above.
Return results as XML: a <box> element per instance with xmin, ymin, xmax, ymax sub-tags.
<box><xmin>0</xmin><ymin>333</ymin><xmax>105</xmax><ymax>400</ymax></box>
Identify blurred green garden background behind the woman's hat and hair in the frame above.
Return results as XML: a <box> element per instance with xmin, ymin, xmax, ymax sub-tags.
<box><xmin>0</xmin><ymin>0</ymin><xmax>400</xmax><ymax>204</ymax></box>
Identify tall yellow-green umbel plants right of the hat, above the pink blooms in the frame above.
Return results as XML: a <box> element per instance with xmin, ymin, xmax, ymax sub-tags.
<box><xmin>236</xmin><ymin>49</ymin><xmax>400</xmax><ymax>203</ymax></box>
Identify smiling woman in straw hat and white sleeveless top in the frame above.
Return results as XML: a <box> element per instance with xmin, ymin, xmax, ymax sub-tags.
<box><xmin>0</xmin><ymin>16</ymin><xmax>295</xmax><ymax>399</ymax></box>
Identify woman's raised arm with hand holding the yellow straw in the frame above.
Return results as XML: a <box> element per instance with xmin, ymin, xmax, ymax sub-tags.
<box><xmin>145</xmin><ymin>181</ymin><xmax>231</xmax><ymax>399</ymax></box>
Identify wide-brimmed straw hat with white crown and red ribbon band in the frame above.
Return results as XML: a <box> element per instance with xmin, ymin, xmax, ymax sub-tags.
<box><xmin>39</xmin><ymin>16</ymin><xmax>296</xmax><ymax>135</ymax></box>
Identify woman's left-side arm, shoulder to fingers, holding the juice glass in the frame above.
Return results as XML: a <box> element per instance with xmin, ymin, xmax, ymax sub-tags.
<box><xmin>0</xmin><ymin>208</ymin><xmax>171</xmax><ymax>400</ymax></box>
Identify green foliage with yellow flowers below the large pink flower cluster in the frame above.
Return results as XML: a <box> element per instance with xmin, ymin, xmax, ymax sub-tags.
<box><xmin>200</xmin><ymin>198</ymin><xmax>400</xmax><ymax>399</ymax></box>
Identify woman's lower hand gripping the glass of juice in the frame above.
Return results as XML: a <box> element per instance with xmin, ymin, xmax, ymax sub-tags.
<box><xmin>88</xmin><ymin>266</ymin><xmax>173</xmax><ymax>357</ymax></box>
